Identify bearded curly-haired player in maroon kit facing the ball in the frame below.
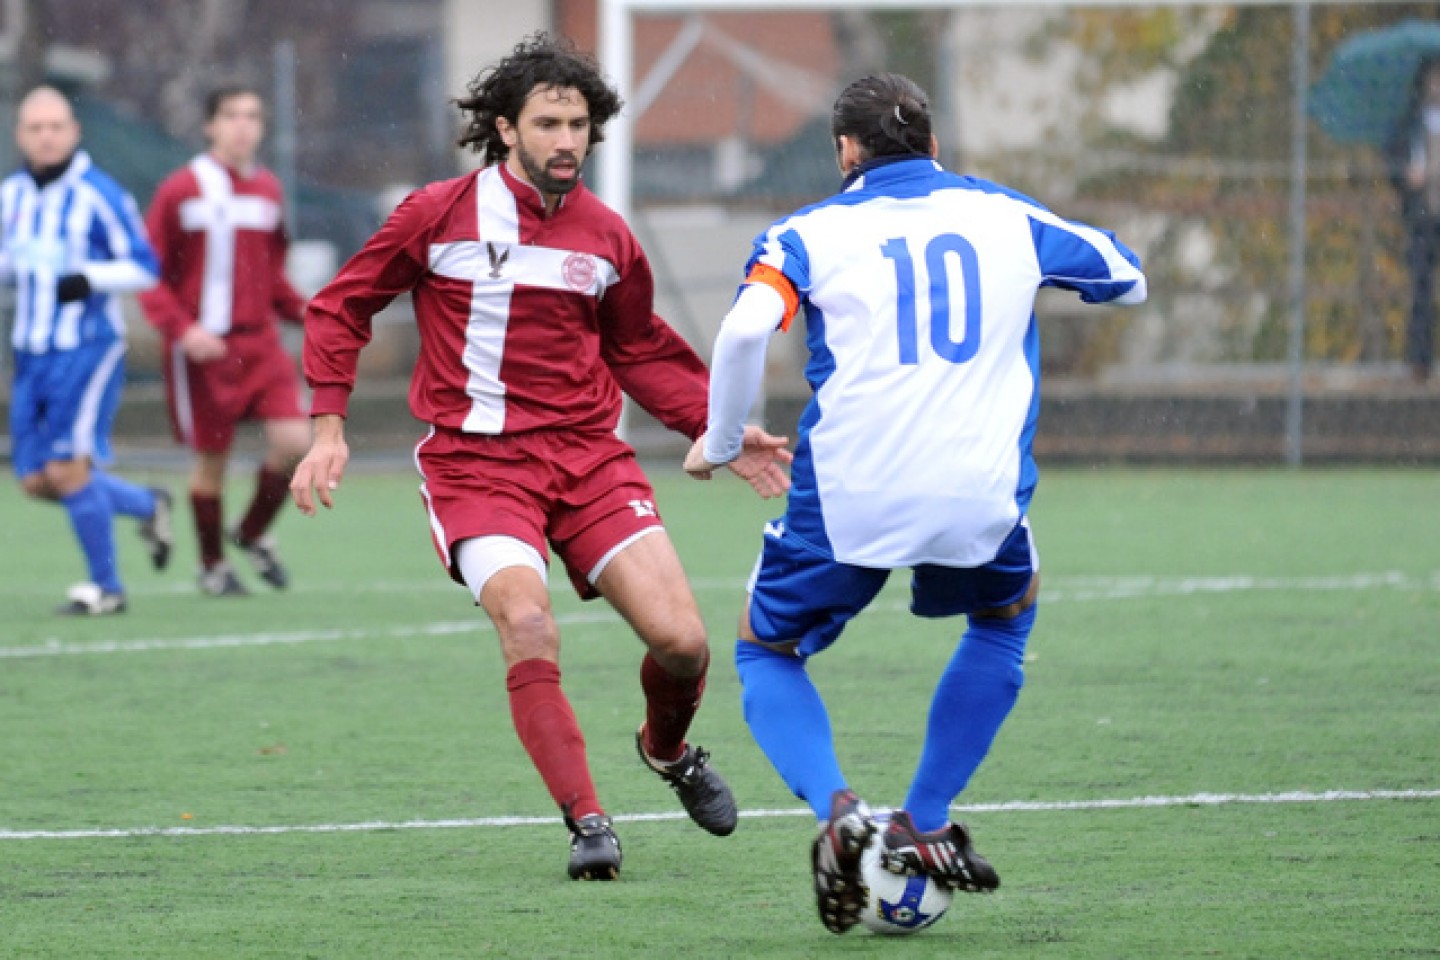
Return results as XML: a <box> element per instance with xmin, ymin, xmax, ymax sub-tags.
<box><xmin>291</xmin><ymin>35</ymin><xmax>789</xmax><ymax>879</ymax></box>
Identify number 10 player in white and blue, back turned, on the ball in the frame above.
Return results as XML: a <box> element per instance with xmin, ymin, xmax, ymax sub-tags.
<box><xmin>685</xmin><ymin>73</ymin><xmax>1146</xmax><ymax>933</ymax></box>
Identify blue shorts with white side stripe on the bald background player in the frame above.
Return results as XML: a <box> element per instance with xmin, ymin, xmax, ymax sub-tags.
<box><xmin>10</xmin><ymin>340</ymin><xmax>125</xmax><ymax>476</ymax></box>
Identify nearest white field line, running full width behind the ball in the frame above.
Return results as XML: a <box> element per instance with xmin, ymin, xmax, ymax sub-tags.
<box><xmin>0</xmin><ymin>790</ymin><xmax>1440</xmax><ymax>841</ymax></box>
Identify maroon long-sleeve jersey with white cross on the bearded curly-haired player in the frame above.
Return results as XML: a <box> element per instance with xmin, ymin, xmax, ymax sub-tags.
<box><xmin>304</xmin><ymin>164</ymin><xmax>707</xmax><ymax>438</ymax></box>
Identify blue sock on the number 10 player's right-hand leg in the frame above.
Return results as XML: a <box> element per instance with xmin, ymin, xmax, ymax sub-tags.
<box><xmin>904</xmin><ymin>607</ymin><xmax>1035</xmax><ymax>832</ymax></box>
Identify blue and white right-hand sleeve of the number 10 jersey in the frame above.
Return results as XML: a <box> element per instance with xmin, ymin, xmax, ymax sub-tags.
<box><xmin>1030</xmin><ymin>210</ymin><xmax>1148</xmax><ymax>304</ymax></box>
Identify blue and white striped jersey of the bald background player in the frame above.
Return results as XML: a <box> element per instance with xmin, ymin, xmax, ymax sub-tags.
<box><xmin>0</xmin><ymin>151</ymin><xmax>160</xmax><ymax>354</ymax></box>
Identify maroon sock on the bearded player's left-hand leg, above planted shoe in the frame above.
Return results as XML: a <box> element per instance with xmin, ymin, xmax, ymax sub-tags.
<box><xmin>505</xmin><ymin>659</ymin><xmax>605</xmax><ymax>820</ymax></box>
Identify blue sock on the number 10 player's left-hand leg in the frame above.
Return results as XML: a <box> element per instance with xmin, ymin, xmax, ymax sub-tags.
<box><xmin>734</xmin><ymin>640</ymin><xmax>845</xmax><ymax>820</ymax></box>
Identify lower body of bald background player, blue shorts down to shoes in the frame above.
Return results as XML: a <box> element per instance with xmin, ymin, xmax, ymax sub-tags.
<box><xmin>10</xmin><ymin>341</ymin><xmax>171</xmax><ymax>615</ymax></box>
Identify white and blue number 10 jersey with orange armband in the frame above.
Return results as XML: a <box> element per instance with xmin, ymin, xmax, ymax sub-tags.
<box><xmin>704</xmin><ymin>157</ymin><xmax>1146</xmax><ymax>569</ymax></box>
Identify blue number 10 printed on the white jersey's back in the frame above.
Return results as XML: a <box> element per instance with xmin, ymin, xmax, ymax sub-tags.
<box><xmin>880</xmin><ymin>233</ymin><xmax>981</xmax><ymax>366</ymax></box>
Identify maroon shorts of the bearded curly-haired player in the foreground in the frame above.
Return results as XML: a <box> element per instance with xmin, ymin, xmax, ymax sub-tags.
<box><xmin>415</xmin><ymin>426</ymin><xmax>661</xmax><ymax>600</ymax></box>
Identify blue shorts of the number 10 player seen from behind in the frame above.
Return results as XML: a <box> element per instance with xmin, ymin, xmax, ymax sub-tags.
<box><xmin>750</xmin><ymin>520</ymin><xmax>1040</xmax><ymax>656</ymax></box>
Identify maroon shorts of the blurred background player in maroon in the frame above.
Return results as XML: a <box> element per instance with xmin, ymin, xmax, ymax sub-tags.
<box><xmin>166</xmin><ymin>325</ymin><xmax>305</xmax><ymax>453</ymax></box>
